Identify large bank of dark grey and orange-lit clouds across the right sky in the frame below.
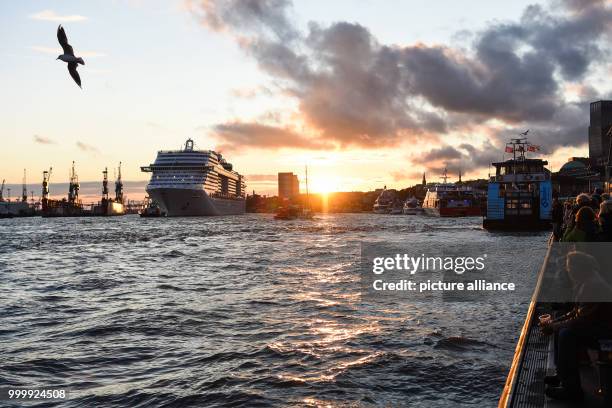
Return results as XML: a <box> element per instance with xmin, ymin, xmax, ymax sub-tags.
<box><xmin>192</xmin><ymin>0</ymin><xmax>612</xmax><ymax>174</ymax></box>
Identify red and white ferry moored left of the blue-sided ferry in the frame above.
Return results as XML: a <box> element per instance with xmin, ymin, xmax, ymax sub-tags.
<box><xmin>423</xmin><ymin>169</ymin><xmax>482</xmax><ymax>217</ymax></box>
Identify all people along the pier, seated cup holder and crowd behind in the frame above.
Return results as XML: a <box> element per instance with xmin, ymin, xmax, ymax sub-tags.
<box><xmin>540</xmin><ymin>189</ymin><xmax>612</xmax><ymax>401</ymax></box>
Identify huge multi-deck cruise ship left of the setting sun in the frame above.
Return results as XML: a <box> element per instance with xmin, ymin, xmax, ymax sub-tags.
<box><xmin>140</xmin><ymin>139</ymin><xmax>246</xmax><ymax>217</ymax></box>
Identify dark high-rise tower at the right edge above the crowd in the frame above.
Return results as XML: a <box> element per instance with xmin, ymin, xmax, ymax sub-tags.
<box><xmin>589</xmin><ymin>101</ymin><xmax>612</xmax><ymax>165</ymax></box>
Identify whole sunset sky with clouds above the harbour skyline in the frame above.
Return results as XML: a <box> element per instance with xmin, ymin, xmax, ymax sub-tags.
<box><xmin>0</xmin><ymin>0</ymin><xmax>612</xmax><ymax>198</ymax></box>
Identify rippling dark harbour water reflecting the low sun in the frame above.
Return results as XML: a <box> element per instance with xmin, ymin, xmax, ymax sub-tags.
<box><xmin>0</xmin><ymin>214</ymin><xmax>545</xmax><ymax>407</ymax></box>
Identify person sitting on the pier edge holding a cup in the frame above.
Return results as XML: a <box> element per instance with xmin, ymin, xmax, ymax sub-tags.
<box><xmin>540</xmin><ymin>251</ymin><xmax>612</xmax><ymax>400</ymax></box>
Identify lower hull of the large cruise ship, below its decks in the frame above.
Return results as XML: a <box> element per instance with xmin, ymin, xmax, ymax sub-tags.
<box><xmin>147</xmin><ymin>188</ymin><xmax>246</xmax><ymax>217</ymax></box>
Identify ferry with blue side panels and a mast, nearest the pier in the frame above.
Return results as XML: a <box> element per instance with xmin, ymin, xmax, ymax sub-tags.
<box><xmin>483</xmin><ymin>135</ymin><xmax>552</xmax><ymax>231</ymax></box>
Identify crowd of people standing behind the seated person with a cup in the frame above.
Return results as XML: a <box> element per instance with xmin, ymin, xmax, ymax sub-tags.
<box><xmin>552</xmin><ymin>189</ymin><xmax>612</xmax><ymax>242</ymax></box>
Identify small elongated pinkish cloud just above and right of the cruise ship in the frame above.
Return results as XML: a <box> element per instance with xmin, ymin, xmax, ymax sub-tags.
<box><xmin>213</xmin><ymin>122</ymin><xmax>331</xmax><ymax>151</ymax></box>
